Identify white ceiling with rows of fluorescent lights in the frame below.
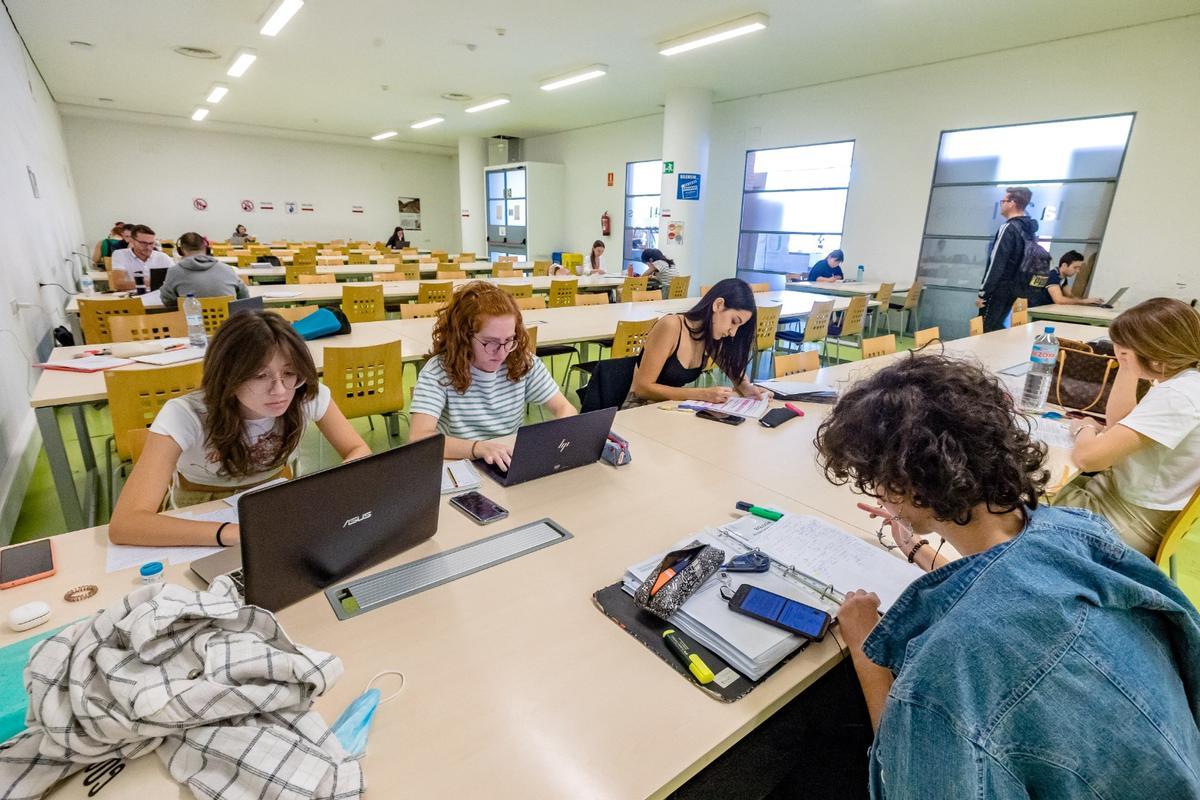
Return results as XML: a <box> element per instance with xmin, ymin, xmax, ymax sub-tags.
<box><xmin>5</xmin><ymin>0</ymin><xmax>1200</xmax><ymax>146</ymax></box>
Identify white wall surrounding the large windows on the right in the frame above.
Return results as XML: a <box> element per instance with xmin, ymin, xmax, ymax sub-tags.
<box><xmin>526</xmin><ymin>17</ymin><xmax>1200</xmax><ymax>300</ymax></box>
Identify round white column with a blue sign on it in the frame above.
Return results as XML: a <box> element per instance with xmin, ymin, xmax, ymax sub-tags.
<box><xmin>659</xmin><ymin>89</ymin><xmax>710</xmax><ymax>294</ymax></box>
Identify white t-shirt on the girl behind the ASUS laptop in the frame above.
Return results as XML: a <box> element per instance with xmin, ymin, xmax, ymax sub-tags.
<box><xmin>150</xmin><ymin>384</ymin><xmax>330</xmax><ymax>486</ymax></box>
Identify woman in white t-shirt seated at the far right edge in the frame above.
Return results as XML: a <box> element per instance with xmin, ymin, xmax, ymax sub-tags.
<box><xmin>1055</xmin><ymin>297</ymin><xmax>1200</xmax><ymax>558</ymax></box>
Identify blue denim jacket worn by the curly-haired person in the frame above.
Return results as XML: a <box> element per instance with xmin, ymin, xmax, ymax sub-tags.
<box><xmin>864</xmin><ymin>507</ymin><xmax>1200</xmax><ymax>800</ymax></box>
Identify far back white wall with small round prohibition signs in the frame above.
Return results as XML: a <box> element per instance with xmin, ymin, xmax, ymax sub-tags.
<box><xmin>64</xmin><ymin>114</ymin><xmax>461</xmax><ymax>251</ymax></box>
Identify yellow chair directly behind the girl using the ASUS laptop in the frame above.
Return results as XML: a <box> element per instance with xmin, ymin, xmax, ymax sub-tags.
<box><xmin>104</xmin><ymin>361</ymin><xmax>204</xmax><ymax>510</ymax></box>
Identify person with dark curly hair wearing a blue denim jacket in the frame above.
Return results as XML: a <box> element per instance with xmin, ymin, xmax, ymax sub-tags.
<box><xmin>816</xmin><ymin>355</ymin><xmax>1200</xmax><ymax>800</ymax></box>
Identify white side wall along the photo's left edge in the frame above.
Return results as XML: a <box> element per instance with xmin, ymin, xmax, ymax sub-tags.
<box><xmin>0</xmin><ymin>16</ymin><xmax>83</xmax><ymax>543</ymax></box>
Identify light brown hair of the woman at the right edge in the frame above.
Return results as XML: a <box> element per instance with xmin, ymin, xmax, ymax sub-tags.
<box><xmin>1109</xmin><ymin>297</ymin><xmax>1200</xmax><ymax>378</ymax></box>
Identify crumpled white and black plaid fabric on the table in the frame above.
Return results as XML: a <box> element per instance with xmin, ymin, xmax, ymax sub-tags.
<box><xmin>0</xmin><ymin>577</ymin><xmax>364</xmax><ymax>800</ymax></box>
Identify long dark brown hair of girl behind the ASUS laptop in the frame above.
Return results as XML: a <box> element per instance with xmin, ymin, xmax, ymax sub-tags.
<box><xmin>200</xmin><ymin>311</ymin><xmax>317</xmax><ymax>476</ymax></box>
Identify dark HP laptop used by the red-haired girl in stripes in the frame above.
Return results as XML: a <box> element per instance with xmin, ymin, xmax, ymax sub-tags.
<box><xmin>475</xmin><ymin>407</ymin><xmax>617</xmax><ymax>486</ymax></box>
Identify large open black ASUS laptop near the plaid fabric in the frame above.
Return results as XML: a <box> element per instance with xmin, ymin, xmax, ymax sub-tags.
<box><xmin>192</xmin><ymin>435</ymin><xmax>445</xmax><ymax>612</ymax></box>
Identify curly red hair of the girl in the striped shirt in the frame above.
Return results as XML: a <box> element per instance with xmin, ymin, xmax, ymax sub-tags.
<box><xmin>430</xmin><ymin>281</ymin><xmax>533</xmax><ymax>395</ymax></box>
